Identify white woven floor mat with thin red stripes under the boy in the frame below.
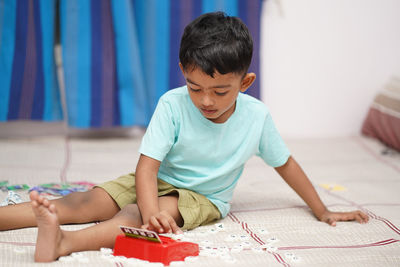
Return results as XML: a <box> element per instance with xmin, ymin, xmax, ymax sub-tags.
<box><xmin>0</xmin><ymin>137</ymin><xmax>400</xmax><ymax>266</ymax></box>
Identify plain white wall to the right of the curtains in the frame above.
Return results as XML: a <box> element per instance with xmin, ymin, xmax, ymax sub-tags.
<box><xmin>261</xmin><ymin>0</ymin><xmax>400</xmax><ymax>138</ymax></box>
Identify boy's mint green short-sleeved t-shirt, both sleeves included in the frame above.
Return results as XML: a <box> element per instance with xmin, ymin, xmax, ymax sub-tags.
<box><xmin>139</xmin><ymin>86</ymin><xmax>290</xmax><ymax>217</ymax></box>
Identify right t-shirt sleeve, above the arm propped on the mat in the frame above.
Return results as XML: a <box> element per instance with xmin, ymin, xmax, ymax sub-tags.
<box><xmin>258</xmin><ymin>113</ymin><xmax>290</xmax><ymax>168</ymax></box>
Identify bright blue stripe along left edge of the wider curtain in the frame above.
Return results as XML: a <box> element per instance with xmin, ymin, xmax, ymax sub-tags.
<box><xmin>60</xmin><ymin>0</ymin><xmax>91</xmax><ymax>128</ymax></box>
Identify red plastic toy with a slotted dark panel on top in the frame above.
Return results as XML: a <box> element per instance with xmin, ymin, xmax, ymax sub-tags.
<box><xmin>114</xmin><ymin>226</ymin><xmax>199</xmax><ymax>265</ymax></box>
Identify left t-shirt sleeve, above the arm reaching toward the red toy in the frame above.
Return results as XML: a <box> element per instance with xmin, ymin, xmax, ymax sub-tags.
<box><xmin>139</xmin><ymin>98</ymin><xmax>175</xmax><ymax>161</ymax></box>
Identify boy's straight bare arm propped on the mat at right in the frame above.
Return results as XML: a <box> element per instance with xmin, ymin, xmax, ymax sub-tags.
<box><xmin>275</xmin><ymin>157</ymin><xmax>368</xmax><ymax>226</ymax></box>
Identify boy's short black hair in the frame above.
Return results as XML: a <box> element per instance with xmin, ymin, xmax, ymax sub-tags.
<box><xmin>179</xmin><ymin>12</ymin><xmax>253</xmax><ymax>77</ymax></box>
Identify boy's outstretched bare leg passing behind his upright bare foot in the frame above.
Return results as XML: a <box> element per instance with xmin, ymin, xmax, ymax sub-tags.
<box><xmin>0</xmin><ymin>187</ymin><xmax>120</xmax><ymax>231</ymax></box>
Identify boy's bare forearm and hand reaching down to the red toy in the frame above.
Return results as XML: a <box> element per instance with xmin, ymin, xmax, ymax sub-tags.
<box><xmin>135</xmin><ymin>154</ymin><xmax>180</xmax><ymax>233</ymax></box>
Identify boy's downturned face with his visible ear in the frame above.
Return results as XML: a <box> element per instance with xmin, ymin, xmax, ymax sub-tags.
<box><xmin>179</xmin><ymin>64</ymin><xmax>255</xmax><ymax>123</ymax></box>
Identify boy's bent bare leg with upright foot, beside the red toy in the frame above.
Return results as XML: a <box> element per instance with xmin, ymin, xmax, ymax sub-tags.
<box><xmin>30</xmin><ymin>192</ymin><xmax>183</xmax><ymax>262</ymax></box>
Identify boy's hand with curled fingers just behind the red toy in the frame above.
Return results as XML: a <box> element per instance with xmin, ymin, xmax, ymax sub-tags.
<box><xmin>142</xmin><ymin>211</ymin><xmax>183</xmax><ymax>234</ymax></box>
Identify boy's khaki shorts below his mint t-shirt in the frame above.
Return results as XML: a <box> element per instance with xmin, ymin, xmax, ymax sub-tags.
<box><xmin>98</xmin><ymin>173</ymin><xmax>221</xmax><ymax>230</ymax></box>
